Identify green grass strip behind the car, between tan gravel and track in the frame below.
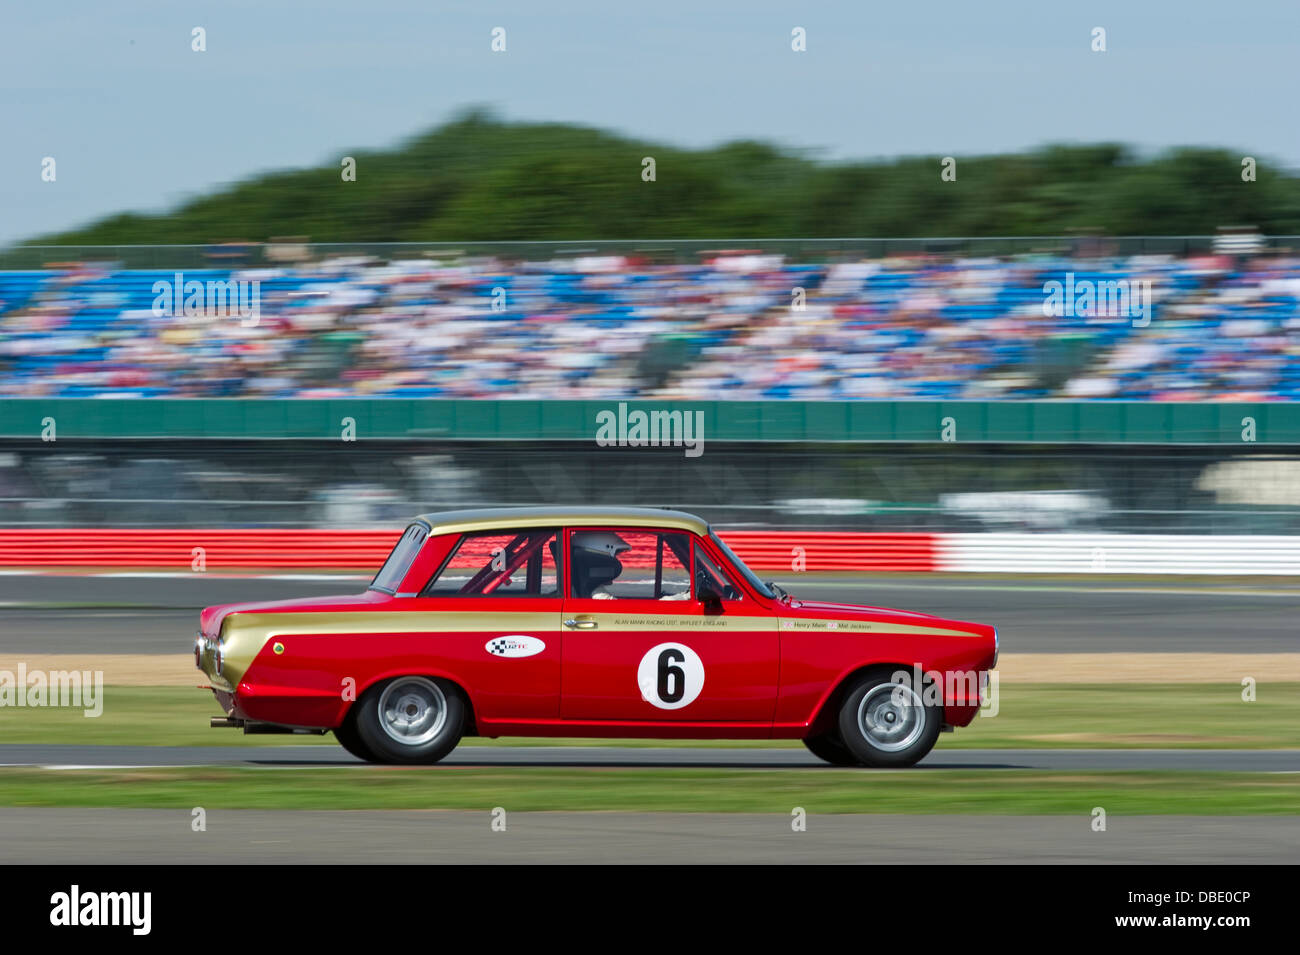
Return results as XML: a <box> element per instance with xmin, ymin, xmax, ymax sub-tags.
<box><xmin>0</xmin><ymin>683</ymin><xmax>1300</xmax><ymax>750</ymax></box>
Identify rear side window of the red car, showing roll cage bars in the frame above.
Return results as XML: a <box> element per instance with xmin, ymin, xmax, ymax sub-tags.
<box><xmin>420</xmin><ymin>528</ymin><xmax>560</xmax><ymax>596</ymax></box>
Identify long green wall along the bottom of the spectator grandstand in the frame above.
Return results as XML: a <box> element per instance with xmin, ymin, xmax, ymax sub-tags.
<box><xmin>0</xmin><ymin>398</ymin><xmax>1300</xmax><ymax>444</ymax></box>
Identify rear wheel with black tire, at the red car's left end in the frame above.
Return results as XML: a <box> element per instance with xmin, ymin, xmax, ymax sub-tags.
<box><xmin>356</xmin><ymin>674</ymin><xmax>465</xmax><ymax>763</ymax></box>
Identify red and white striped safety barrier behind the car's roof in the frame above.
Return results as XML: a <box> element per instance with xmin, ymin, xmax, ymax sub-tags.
<box><xmin>0</xmin><ymin>529</ymin><xmax>1300</xmax><ymax>576</ymax></box>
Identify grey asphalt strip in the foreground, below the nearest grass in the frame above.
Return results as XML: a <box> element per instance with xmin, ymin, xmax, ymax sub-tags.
<box><xmin>0</xmin><ymin>808</ymin><xmax>1300</xmax><ymax>865</ymax></box>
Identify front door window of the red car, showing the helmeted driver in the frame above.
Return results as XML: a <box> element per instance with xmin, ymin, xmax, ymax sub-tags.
<box><xmin>569</xmin><ymin>528</ymin><xmax>690</xmax><ymax>600</ymax></box>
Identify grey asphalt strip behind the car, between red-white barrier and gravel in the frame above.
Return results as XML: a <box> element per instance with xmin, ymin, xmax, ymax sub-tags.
<box><xmin>0</xmin><ymin>574</ymin><xmax>1300</xmax><ymax>654</ymax></box>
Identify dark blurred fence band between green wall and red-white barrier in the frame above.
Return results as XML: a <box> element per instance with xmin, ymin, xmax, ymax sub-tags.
<box><xmin>0</xmin><ymin>440</ymin><xmax>1300</xmax><ymax>534</ymax></box>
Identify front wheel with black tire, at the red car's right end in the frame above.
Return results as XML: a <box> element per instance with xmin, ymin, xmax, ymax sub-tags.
<box><xmin>840</xmin><ymin>670</ymin><xmax>944</xmax><ymax>767</ymax></box>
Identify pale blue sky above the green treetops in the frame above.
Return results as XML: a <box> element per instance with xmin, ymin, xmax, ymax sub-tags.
<box><xmin>0</xmin><ymin>0</ymin><xmax>1300</xmax><ymax>240</ymax></box>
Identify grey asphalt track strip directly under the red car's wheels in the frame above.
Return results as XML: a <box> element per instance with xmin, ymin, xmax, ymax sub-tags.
<box><xmin>0</xmin><ymin>741</ymin><xmax>1300</xmax><ymax>774</ymax></box>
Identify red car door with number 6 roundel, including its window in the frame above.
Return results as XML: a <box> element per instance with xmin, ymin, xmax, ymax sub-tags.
<box><xmin>560</xmin><ymin>528</ymin><xmax>779</xmax><ymax>724</ymax></box>
